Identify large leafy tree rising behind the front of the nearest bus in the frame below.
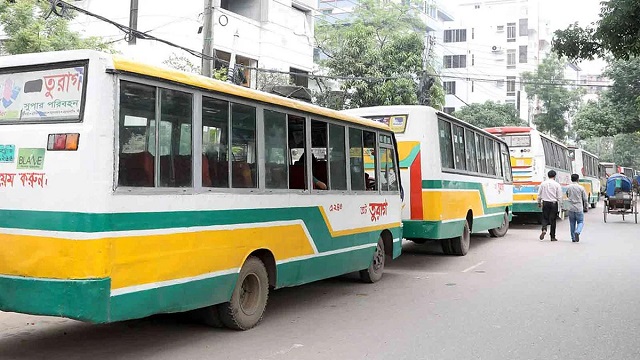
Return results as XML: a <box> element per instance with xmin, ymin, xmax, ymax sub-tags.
<box><xmin>315</xmin><ymin>0</ymin><xmax>444</xmax><ymax>107</ymax></box>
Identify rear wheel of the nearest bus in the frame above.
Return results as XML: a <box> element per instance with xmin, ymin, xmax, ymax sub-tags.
<box><xmin>218</xmin><ymin>256</ymin><xmax>269</xmax><ymax>330</ymax></box>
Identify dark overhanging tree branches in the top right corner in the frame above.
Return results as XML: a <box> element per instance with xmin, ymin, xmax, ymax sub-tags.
<box><xmin>553</xmin><ymin>0</ymin><xmax>640</xmax><ymax>61</ymax></box>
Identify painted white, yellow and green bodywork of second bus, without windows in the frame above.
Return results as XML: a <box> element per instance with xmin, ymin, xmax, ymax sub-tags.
<box><xmin>345</xmin><ymin>106</ymin><xmax>513</xmax><ymax>240</ymax></box>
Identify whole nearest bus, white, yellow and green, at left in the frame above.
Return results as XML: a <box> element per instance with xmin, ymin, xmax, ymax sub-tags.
<box><xmin>0</xmin><ymin>51</ymin><xmax>402</xmax><ymax>329</ymax></box>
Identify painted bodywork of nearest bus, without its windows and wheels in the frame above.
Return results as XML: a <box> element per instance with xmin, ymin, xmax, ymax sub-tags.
<box><xmin>0</xmin><ymin>51</ymin><xmax>402</xmax><ymax>323</ymax></box>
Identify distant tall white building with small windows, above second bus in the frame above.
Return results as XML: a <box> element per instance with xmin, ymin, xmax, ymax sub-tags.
<box><xmin>439</xmin><ymin>0</ymin><xmax>551</xmax><ymax>120</ymax></box>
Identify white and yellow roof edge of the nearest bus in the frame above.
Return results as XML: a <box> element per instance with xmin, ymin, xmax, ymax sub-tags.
<box><xmin>0</xmin><ymin>50</ymin><xmax>391</xmax><ymax>131</ymax></box>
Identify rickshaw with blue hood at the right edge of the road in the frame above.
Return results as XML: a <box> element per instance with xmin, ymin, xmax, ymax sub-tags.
<box><xmin>603</xmin><ymin>174</ymin><xmax>638</xmax><ymax>224</ymax></box>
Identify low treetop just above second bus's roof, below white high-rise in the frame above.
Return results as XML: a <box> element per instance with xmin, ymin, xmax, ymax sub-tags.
<box><xmin>453</xmin><ymin>101</ymin><xmax>525</xmax><ymax>128</ymax></box>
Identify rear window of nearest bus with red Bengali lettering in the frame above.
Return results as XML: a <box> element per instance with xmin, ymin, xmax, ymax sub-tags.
<box><xmin>0</xmin><ymin>62</ymin><xmax>86</xmax><ymax>124</ymax></box>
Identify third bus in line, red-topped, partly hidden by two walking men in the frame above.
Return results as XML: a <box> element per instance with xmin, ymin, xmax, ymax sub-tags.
<box><xmin>485</xmin><ymin>126</ymin><xmax>571</xmax><ymax>218</ymax></box>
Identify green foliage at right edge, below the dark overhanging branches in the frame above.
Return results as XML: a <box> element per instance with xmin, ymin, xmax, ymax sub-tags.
<box><xmin>574</xmin><ymin>58</ymin><xmax>640</xmax><ymax>139</ymax></box>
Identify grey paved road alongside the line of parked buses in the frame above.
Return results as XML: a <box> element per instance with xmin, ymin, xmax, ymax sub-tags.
<box><xmin>0</xmin><ymin>205</ymin><xmax>640</xmax><ymax>360</ymax></box>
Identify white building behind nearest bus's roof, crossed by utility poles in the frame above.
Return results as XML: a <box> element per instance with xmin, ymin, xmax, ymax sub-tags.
<box><xmin>71</xmin><ymin>0</ymin><xmax>317</xmax><ymax>87</ymax></box>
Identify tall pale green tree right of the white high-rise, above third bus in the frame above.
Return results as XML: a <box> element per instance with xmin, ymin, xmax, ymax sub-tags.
<box><xmin>522</xmin><ymin>54</ymin><xmax>582</xmax><ymax>139</ymax></box>
